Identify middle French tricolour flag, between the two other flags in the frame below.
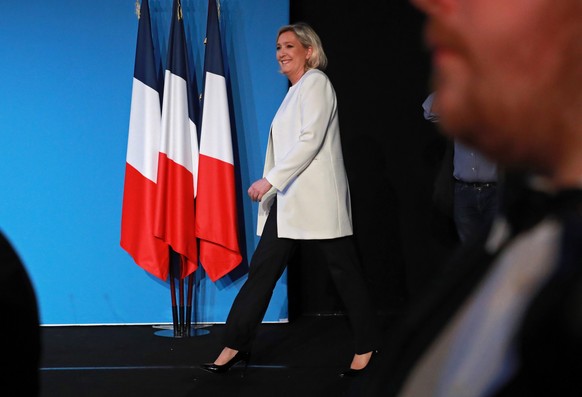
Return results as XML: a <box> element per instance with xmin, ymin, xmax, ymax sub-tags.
<box><xmin>155</xmin><ymin>0</ymin><xmax>198</xmax><ymax>278</ymax></box>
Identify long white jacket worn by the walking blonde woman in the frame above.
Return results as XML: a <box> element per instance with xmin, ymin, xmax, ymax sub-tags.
<box><xmin>257</xmin><ymin>69</ymin><xmax>353</xmax><ymax>239</ymax></box>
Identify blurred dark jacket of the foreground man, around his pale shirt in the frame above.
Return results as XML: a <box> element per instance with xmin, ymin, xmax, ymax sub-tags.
<box><xmin>349</xmin><ymin>178</ymin><xmax>582</xmax><ymax>397</ymax></box>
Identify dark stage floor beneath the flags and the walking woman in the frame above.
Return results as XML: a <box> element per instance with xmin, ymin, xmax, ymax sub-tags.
<box><xmin>41</xmin><ymin>315</ymin><xmax>400</xmax><ymax>397</ymax></box>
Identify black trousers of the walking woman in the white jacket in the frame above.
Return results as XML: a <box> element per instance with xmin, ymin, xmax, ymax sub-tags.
<box><xmin>223</xmin><ymin>202</ymin><xmax>380</xmax><ymax>354</ymax></box>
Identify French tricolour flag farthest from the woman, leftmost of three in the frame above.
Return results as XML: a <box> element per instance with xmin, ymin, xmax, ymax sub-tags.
<box><xmin>121</xmin><ymin>0</ymin><xmax>169</xmax><ymax>280</ymax></box>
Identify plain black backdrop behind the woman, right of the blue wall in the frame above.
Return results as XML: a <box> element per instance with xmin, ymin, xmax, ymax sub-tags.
<box><xmin>289</xmin><ymin>0</ymin><xmax>455</xmax><ymax>317</ymax></box>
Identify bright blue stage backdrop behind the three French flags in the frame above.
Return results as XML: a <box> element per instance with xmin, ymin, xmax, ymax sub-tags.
<box><xmin>0</xmin><ymin>0</ymin><xmax>289</xmax><ymax>326</ymax></box>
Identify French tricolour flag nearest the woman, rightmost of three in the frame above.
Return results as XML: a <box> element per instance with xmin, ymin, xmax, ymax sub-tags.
<box><xmin>196</xmin><ymin>0</ymin><xmax>242</xmax><ymax>281</ymax></box>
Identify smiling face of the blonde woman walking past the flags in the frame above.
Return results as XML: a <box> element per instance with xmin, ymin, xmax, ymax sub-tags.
<box><xmin>277</xmin><ymin>32</ymin><xmax>311</xmax><ymax>84</ymax></box>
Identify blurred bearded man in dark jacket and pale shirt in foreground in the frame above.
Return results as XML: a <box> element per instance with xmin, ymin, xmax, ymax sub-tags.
<box><xmin>351</xmin><ymin>0</ymin><xmax>582</xmax><ymax>397</ymax></box>
